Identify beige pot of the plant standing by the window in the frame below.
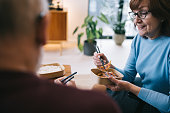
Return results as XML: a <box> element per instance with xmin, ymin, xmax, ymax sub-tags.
<box><xmin>113</xmin><ymin>34</ymin><xmax>125</xmax><ymax>45</ymax></box>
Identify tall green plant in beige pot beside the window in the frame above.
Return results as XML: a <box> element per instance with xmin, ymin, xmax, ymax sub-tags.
<box><xmin>98</xmin><ymin>0</ymin><xmax>126</xmax><ymax>45</ymax></box>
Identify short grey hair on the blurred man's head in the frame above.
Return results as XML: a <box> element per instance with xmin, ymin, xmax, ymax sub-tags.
<box><xmin>0</xmin><ymin>0</ymin><xmax>48</xmax><ymax>39</ymax></box>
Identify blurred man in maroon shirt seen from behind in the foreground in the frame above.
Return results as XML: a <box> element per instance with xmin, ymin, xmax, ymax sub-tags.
<box><xmin>0</xmin><ymin>0</ymin><xmax>119</xmax><ymax>113</ymax></box>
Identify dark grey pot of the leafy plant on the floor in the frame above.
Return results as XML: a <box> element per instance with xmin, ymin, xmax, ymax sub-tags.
<box><xmin>83</xmin><ymin>40</ymin><xmax>97</xmax><ymax>56</ymax></box>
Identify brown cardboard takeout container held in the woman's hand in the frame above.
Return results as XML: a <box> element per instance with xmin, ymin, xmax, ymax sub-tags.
<box><xmin>91</xmin><ymin>68</ymin><xmax>123</xmax><ymax>85</ymax></box>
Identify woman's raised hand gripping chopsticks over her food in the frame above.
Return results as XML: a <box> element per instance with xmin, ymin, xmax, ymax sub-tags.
<box><xmin>93</xmin><ymin>52</ymin><xmax>108</xmax><ymax>66</ymax></box>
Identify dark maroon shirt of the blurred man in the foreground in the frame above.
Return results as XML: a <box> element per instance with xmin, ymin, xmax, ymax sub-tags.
<box><xmin>0</xmin><ymin>71</ymin><xmax>120</xmax><ymax>113</ymax></box>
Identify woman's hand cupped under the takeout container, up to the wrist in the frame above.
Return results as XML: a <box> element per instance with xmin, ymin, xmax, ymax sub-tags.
<box><xmin>107</xmin><ymin>77</ymin><xmax>131</xmax><ymax>91</ymax></box>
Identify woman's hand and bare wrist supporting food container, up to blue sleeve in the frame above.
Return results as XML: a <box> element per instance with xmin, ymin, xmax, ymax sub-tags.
<box><xmin>107</xmin><ymin>77</ymin><xmax>141</xmax><ymax>96</ymax></box>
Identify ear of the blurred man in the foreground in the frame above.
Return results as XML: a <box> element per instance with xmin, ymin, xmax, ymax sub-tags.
<box><xmin>35</xmin><ymin>15</ymin><xmax>49</xmax><ymax>45</ymax></box>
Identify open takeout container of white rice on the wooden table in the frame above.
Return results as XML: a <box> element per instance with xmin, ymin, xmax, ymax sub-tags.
<box><xmin>37</xmin><ymin>63</ymin><xmax>65</xmax><ymax>79</ymax></box>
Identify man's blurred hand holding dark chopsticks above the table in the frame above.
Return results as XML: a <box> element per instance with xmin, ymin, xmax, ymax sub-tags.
<box><xmin>54</xmin><ymin>77</ymin><xmax>76</xmax><ymax>88</ymax></box>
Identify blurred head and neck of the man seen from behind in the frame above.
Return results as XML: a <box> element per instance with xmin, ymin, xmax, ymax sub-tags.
<box><xmin>0</xmin><ymin>0</ymin><xmax>48</xmax><ymax>71</ymax></box>
